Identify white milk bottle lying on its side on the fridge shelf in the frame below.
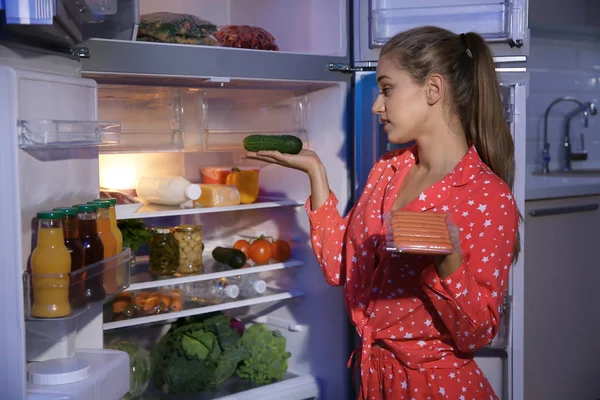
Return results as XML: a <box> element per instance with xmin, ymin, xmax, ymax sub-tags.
<box><xmin>136</xmin><ymin>175</ymin><xmax>202</xmax><ymax>206</ymax></box>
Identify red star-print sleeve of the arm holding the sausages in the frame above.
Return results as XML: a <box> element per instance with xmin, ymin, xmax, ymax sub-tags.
<box><xmin>421</xmin><ymin>193</ymin><xmax>519</xmax><ymax>353</ymax></box>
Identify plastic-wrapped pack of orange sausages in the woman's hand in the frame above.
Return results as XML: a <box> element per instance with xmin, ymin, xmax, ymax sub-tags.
<box><xmin>384</xmin><ymin>210</ymin><xmax>459</xmax><ymax>255</ymax></box>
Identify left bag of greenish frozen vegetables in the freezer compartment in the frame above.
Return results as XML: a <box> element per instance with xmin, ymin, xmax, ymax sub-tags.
<box><xmin>137</xmin><ymin>12</ymin><xmax>219</xmax><ymax>46</ymax></box>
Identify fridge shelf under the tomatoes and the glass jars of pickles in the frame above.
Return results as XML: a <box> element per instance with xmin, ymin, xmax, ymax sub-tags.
<box><xmin>128</xmin><ymin>256</ymin><xmax>304</xmax><ymax>290</ymax></box>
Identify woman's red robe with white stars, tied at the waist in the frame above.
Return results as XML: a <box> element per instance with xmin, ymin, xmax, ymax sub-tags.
<box><xmin>306</xmin><ymin>146</ymin><xmax>519</xmax><ymax>400</ymax></box>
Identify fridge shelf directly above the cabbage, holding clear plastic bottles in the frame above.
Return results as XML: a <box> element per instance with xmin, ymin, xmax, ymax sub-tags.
<box><xmin>103</xmin><ymin>288</ymin><xmax>304</xmax><ymax>331</ymax></box>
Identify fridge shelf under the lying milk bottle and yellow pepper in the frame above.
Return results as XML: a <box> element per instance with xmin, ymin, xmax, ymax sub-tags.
<box><xmin>117</xmin><ymin>197</ymin><xmax>304</xmax><ymax>220</ymax></box>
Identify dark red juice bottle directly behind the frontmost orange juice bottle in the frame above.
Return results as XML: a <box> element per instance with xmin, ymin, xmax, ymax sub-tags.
<box><xmin>54</xmin><ymin>207</ymin><xmax>86</xmax><ymax>309</ymax></box>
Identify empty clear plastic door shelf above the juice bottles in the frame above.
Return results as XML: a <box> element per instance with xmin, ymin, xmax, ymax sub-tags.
<box><xmin>17</xmin><ymin>119</ymin><xmax>121</xmax><ymax>149</ymax></box>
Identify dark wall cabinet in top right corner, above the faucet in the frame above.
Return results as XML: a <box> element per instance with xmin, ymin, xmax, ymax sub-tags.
<box><xmin>529</xmin><ymin>0</ymin><xmax>600</xmax><ymax>35</ymax></box>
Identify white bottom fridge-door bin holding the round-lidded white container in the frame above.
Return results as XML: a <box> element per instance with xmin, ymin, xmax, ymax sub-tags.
<box><xmin>26</xmin><ymin>349</ymin><xmax>129</xmax><ymax>400</ymax></box>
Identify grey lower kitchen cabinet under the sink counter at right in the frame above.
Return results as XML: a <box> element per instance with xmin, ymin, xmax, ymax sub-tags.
<box><xmin>524</xmin><ymin>196</ymin><xmax>600</xmax><ymax>400</ymax></box>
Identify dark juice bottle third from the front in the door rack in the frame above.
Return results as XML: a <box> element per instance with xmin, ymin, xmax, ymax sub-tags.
<box><xmin>73</xmin><ymin>204</ymin><xmax>105</xmax><ymax>301</ymax></box>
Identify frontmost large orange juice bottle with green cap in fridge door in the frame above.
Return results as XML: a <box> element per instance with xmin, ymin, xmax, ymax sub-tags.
<box><xmin>31</xmin><ymin>211</ymin><xmax>71</xmax><ymax>318</ymax></box>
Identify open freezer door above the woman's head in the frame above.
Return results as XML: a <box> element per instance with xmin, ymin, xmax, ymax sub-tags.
<box><xmin>353</xmin><ymin>0</ymin><xmax>528</xmax><ymax>63</ymax></box>
